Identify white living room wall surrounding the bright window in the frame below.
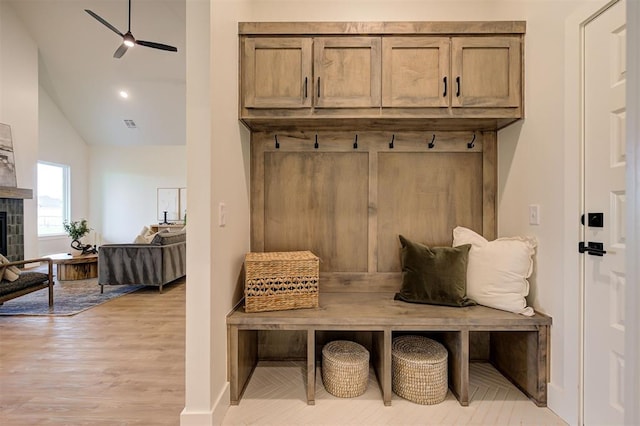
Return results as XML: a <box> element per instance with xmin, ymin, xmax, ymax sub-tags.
<box><xmin>39</xmin><ymin>86</ymin><xmax>90</xmax><ymax>256</ymax></box>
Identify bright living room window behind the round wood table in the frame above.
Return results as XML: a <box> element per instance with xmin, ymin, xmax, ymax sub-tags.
<box><xmin>37</xmin><ymin>161</ymin><xmax>70</xmax><ymax>237</ymax></box>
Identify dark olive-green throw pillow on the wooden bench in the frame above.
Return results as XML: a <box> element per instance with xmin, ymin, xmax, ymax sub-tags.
<box><xmin>395</xmin><ymin>235</ymin><xmax>476</xmax><ymax>306</ymax></box>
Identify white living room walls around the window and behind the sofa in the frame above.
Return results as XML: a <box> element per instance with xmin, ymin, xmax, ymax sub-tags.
<box><xmin>0</xmin><ymin>1</ymin><xmax>186</xmax><ymax>258</ymax></box>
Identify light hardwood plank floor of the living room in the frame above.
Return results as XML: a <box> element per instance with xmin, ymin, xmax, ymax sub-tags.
<box><xmin>0</xmin><ymin>282</ymin><xmax>185</xmax><ymax>426</ymax></box>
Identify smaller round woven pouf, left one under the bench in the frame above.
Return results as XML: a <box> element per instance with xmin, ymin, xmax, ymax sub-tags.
<box><xmin>322</xmin><ymin>340</ymin><xmax>369</xmax><ymax>398</ymax></box>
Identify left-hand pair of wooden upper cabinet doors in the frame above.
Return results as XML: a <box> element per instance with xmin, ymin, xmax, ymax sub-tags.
<box><xmin>241</xmin><ymin>37</ymin><xmax>380</xmax><ymax>110</ymax></box>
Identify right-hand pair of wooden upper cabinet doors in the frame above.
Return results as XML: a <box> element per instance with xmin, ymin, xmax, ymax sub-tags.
<box><xmin>382</xmin><ymin>36</ymin><xmax>522</xmax><ymax>113</ymax></box>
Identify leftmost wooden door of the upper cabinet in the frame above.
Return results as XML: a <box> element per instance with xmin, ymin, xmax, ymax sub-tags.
<box><xmin>242</xmin><ymin>37</ymin><xmax>313</xmax><ymax>108</ymax></box>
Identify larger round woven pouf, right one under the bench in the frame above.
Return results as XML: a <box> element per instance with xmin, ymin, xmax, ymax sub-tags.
<box><xmin>391</xmin><ymin>336</ymin><xmax>448</xmax><ymax>405</ymax></box>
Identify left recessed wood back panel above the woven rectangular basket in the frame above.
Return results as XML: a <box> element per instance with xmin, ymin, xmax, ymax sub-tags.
<box><xmin>264</xmin><ymin>151</ymin><xmax>369</xmax><ymax>272</ymax></box>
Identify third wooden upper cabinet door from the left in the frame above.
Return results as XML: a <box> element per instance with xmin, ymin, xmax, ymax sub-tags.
<box><xmin>382</xmin><ymin>37</ymin><xmax>451</xmax><ymax>108</ymax></box>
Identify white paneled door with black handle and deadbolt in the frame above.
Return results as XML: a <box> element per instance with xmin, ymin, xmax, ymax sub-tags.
<box><xmin>583</xmin><ymin>0</ymin><xmax>626</xmax><ymax>425</ymax></box>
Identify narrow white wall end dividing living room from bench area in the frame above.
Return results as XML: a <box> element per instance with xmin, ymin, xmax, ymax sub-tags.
<box><xmin>180</xmin><ymin>0</ymin><xmax>215</xmax><ymax>426</ymax></box>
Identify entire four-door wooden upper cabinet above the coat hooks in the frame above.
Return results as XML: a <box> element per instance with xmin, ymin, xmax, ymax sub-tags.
<box><xmin>239</xmin><ymin>22</ymin><xmax>525</xmax><ymax>130</ymax></box>
